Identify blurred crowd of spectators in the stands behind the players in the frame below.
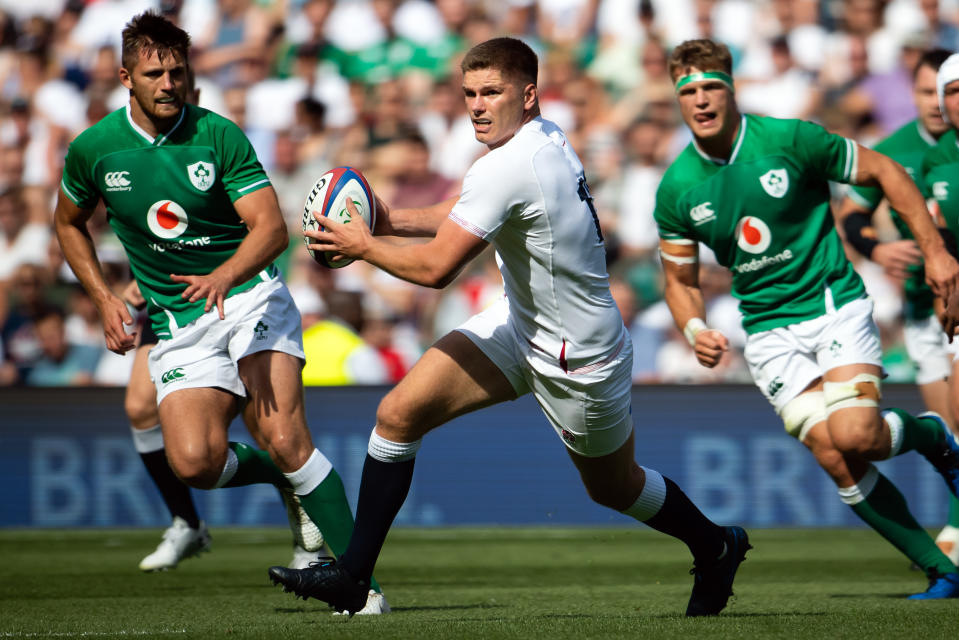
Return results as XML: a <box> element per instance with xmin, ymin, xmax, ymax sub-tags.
<box><xmin>0</xmin><ymin>0</ymin><xmax>959</xmax><ymax>385</ymax></box>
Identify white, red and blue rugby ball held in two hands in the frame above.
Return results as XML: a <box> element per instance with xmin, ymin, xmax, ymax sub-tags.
<box><xmin>303</xmin><ymin>167</ymin><xmax>376</xmax><ymax>269</ymax></box>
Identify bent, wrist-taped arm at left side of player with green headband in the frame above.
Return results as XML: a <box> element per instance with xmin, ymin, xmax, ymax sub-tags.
<box><xmin>659</xmin><ymin>239</ymin><xmax>729</xmax><ymax>369</ymax></box>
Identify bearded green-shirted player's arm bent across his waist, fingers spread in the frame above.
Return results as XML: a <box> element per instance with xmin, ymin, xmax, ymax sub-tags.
<box><xmin>170</xmin><ymin>187</ymin><xmax>290</xmax><ymax>320</ymax></box>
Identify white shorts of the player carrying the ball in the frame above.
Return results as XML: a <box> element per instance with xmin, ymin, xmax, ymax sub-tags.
<box><xmin>456</xmin><ymin>299</ymin><xmax>633</xmax><ymax>458</ymax></box>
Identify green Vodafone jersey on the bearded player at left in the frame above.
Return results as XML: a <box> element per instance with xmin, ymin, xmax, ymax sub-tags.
<box><xmin>60</xmin><ymin>105</ymin><xmax>277</xmax><ymax>338</ymax></box>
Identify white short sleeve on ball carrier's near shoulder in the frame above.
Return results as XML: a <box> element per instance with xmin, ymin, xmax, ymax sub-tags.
<box><xmin>449</xmin><ymin>155</ymin><xmax>516</xmax><ymax>241</ymax></box>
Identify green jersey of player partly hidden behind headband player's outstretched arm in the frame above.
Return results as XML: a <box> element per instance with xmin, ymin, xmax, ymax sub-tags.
<box><xmin>849</xmin><ymin>119</ymin><xmax>936</xmax><ymax>320</ymax></box>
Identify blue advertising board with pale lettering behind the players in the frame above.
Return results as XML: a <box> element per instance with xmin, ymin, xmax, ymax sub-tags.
<box><xmin>0</xmin><ymin>385</ymin><xmax>948</xmax><ymax>527</ymax></box>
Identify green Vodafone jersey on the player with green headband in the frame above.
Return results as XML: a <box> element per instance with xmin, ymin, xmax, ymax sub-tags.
<box><xmin>654</xmin><ymin>115</ymin><xmax>865</xmax><ymax>333</ymax></box>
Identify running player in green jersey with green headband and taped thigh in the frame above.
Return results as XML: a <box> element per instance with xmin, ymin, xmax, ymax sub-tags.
<box><xmin>654</xmin><ymin>40</ymin><xmax>959</xmax><ymax>599</ymax></box>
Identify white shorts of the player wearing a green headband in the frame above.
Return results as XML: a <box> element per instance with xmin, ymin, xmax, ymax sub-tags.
<box><xmin>744</xmin><ymin>298</ymin><xmax>882</xmax><ymax>413</ymax></box>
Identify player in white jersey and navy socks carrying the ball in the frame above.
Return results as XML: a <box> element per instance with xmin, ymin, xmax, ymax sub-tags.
<box><xmin>270</xmin><ymin>38</ymin><xmax>749</xmax><ymax>616</ymax></box>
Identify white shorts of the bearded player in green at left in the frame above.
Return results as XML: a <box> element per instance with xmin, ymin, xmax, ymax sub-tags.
<box><xmin>149</xmin><ymin>278</ymin><xmax>306</xmax><ymax>405</ymax></box>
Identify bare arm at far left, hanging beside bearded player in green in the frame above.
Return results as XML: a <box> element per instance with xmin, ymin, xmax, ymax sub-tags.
<box><xmin>53</xmin><ymin>190</ymin><xmax>136</xmax><ymax>354</ymax></box>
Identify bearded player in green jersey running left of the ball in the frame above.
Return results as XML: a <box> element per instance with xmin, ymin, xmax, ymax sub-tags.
<box><xmin>54</xmin><ymin>12</ymin><xmax>388</xmax><ymax>613</ymax></box>
